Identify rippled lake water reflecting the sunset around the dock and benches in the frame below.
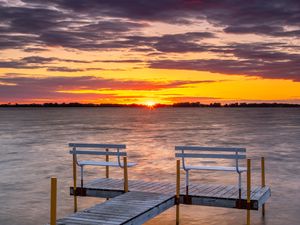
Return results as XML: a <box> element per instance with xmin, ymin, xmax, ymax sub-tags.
<box><xmin>0</xmin><ymin>108</ymin><xmax>300</xmax><ymax>225</ymax></box>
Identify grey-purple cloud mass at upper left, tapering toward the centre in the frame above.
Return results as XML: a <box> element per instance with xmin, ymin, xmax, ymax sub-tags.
<box><xmin>0</xmin><ymin>1</ymin><xmax>148</xmax><ymax>49</ymax></box>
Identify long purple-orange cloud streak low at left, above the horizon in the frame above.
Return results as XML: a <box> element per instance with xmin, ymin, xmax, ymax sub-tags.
<box><xmin>0</xmin><ymin>76</ymin><xmax>207</xmax><ymax>101</ymax></box>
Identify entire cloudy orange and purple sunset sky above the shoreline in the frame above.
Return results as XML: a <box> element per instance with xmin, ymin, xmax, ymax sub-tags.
<box><xmin>0</xmin><ymin>0</ymin><xmax>300</xmax><ymax>104</ymax></box>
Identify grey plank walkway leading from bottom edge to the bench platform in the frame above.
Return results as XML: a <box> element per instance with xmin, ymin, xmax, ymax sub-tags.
<box><xmin>57</xmin><ymin>192</ymin><xmax>175</xmax><ymax>225</ymax></box>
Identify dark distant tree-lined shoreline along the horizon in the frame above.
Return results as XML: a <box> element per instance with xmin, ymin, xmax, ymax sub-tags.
<box><xmin>0</xmin><ymin>102</ymin><xmax>300</xmax><ymax>108</ymax></box>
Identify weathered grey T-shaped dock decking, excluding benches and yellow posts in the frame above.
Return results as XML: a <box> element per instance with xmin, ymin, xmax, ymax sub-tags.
<box><xmin>52</xmin><ymin>178</ymin><xmax>271</xmax><ymax>225</ymax></box>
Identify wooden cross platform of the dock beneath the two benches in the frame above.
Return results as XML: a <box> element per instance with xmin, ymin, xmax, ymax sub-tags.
<box><xmin>70</xmin><ymin>178</ymin><xmax>271</xmax><ymax>210</ymax></box>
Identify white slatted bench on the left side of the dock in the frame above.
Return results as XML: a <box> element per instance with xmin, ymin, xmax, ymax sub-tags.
<box><xmin>69</xmin><ymin>143</ymin><xmax>136</xmax><ymax>188</ymax></box>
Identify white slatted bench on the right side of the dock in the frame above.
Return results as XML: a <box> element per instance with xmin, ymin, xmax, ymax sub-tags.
<box><xmin>175</xmin><ymin>146</ymin><xmax>247</xmax><ymax>197</ymax></box>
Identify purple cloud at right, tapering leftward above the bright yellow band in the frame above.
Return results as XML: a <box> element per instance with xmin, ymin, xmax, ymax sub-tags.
<box><xmin>149</xmin><ymin>43</ymin><xmax>300</xmax><ymax>82</ymax></box>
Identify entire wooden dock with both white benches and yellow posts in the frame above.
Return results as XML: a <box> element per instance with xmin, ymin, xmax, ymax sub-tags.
<box><xmin>50</xmin><ymin>144</ymin><xmax>271</xmax><ymax>225</ymax></box>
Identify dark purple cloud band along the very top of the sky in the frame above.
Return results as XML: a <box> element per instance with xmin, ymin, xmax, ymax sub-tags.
<box><xmin>20</xmin><ymin>0</ymin><xmax>300</xmax><ymax>36</ymax></box>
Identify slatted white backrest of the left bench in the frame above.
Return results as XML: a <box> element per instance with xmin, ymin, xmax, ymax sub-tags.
<box><xmin>69</xmin><ymin>143</ymin><xmax>127</xmax><ymax>166</ymax></box>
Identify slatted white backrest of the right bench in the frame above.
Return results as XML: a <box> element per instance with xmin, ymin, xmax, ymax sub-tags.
<box><xmin>175</xmin><ymin>146</ymin><xmax>246</xmax><ymax>170</ymax></box>
